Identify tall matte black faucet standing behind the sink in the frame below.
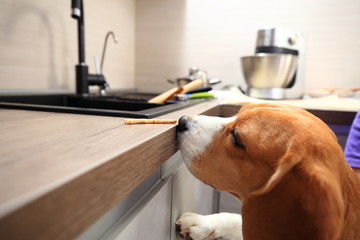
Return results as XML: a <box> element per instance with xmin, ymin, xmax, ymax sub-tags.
<box><xmin>71</xmin><ymin>0</ymin><xmax>108</xmax><ymax>95</ymax></box>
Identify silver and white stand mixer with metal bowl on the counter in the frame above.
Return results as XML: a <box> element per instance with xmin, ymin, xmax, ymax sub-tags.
<box><xmin>241</xmin><ymin>28</ymin><xmax>305</xmax><ymax>99</ymax></box>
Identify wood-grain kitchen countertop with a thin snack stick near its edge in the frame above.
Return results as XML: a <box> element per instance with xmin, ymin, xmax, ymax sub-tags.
<box><xmin>0</xmin><ymin>98</ymin><xmax>355</xmax><ymax>239</ymax></box>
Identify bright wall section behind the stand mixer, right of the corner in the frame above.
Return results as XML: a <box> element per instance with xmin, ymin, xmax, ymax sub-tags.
<box><xmin>135</xmin><ymin>0</ymin><xmax>360</xmax><ymax>91</ymax></box>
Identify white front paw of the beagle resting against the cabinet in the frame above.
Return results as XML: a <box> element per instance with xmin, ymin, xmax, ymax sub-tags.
<box><xmin>176</xmin><ymin>213</ymin><xmax>243</xmax><ymax>240</ymax></box>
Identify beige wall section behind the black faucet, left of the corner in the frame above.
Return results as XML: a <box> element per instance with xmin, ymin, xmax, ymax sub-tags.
<box><xmin>0</xmin><ymin>0</ymin><xmax>135</xmax><ymax>90</ymax></box>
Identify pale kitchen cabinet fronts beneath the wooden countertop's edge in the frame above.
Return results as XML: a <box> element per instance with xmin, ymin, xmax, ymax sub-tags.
<box><xmin>77</xmin><ymin>152</ymin><xmax>218</xmax><ymax>240</ymax></box>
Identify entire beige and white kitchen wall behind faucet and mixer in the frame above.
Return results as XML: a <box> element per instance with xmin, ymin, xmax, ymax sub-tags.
<box><xmin>0</xmin><ymin>0</ymin><xmax>360</xmax><ymax>92</ymax></box>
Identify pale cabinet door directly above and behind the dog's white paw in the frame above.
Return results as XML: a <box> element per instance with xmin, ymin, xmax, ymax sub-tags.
<box><xmin>170</xmin><ymin>164</ymin><xmax>217</xmax><ymax>240</ymax></box>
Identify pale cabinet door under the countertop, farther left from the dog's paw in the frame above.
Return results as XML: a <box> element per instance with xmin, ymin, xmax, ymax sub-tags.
<box><xmin>106</xmin><ymin>179</ymin><xmax>172</xmax><ymax>240</ymax></box>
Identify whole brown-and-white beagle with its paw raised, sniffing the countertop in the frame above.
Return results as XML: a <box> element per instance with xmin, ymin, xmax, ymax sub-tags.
<box><xmin>176</xmin><ymin>104</ymin><xmax>360</xmax><ymax>240</ymax></box>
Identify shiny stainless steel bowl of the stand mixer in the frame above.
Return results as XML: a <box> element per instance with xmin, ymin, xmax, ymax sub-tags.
<box><xmin>241</xmin><ymin>53</ymin><xmax>297</xmax><ymax>88</ymax></box>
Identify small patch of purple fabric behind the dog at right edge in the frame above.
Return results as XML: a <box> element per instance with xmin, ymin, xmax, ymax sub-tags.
<box><xmin>345</xmin><ymin>111</ymin><xmax>360</xmax><ymax>168</ymax></box>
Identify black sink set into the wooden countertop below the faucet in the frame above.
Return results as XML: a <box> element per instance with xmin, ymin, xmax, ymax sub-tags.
<box><xmin>0</xmin><ymin>93</ymin><xmax>203</xmax><ymax>118</ymax></box>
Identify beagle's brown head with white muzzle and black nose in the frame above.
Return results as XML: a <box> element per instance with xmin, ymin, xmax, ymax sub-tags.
<box><xmin>178</xmin><ymin>104</ymin><xmax>341</xmax><ymax>199</ymax></box>
